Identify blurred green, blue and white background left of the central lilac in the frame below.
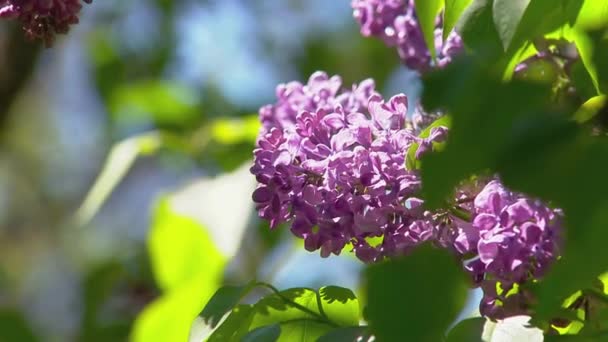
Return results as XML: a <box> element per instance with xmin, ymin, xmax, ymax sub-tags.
<box><xmin>0</xmin><ymin>0</ymin><xmax>419</xmax><ymax>341</ymax></box>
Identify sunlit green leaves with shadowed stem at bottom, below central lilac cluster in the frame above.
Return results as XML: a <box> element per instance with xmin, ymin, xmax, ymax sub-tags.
<box><xmin>201</xmin><ymin>283</ymin><xmax>359</xmax><ymax>341</ymax></box>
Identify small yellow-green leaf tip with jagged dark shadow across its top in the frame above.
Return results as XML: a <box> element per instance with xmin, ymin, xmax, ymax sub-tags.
<box><xmin>319</xmin><ymin>286</ymin><xmax>359</xmax><ymax>326</ymax></box>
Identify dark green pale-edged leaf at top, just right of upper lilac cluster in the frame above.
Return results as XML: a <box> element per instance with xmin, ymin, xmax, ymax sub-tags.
<box><xmin>456</xmin><ymin>0</ymin><xmax>503</xmax><ymax>59</ymax></box>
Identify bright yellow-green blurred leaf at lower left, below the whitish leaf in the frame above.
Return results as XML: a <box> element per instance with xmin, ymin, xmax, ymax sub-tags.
<box><xmin>132</xmin><ymin>199</ymin><xmax>226</xmax><ymax>342</ymax></box>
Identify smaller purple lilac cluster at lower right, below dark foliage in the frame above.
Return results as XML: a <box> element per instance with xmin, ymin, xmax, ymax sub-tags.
<box><xmin>454</xmin><ymin>180</ymin><xmax>562</xmax><ymax>318</ymax></box>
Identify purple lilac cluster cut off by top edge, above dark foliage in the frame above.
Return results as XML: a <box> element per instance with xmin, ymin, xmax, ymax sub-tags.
<box><xmin>351</xmin><ymin>0</ymin><xmax>463</xmax><ymax>72</ymax></box>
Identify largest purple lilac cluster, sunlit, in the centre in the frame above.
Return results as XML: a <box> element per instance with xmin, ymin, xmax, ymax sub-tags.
<box><xmin>251</xmin><ymin>72</ymin><xmax>443</xmax><ymax>262</ymax></box>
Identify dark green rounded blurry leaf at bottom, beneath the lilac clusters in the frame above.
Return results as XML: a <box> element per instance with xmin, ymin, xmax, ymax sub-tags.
<box><xmin>365</xmin><ymin>245</ymin><xmax>467</xmax><ymax>342</ymax></box>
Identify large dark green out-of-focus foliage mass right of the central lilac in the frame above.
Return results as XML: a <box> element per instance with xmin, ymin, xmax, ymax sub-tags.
<box><xmin>422</xmin><ymin>30</ymin><xmax>608</xmax><ymax>318</ymax></box>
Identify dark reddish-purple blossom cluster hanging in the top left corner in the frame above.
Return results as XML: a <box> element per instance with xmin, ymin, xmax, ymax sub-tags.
<box><xmin>0</xmin><ymin>0</ymin><xmax>92</xmax><ymax>45</ymax></box>
